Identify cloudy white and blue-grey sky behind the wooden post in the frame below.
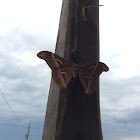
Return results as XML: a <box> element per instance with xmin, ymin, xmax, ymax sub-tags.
<box><xmin>0</xmin><ymin>0</ymin><xmax>140</xmax><ymax>140</ymax></box>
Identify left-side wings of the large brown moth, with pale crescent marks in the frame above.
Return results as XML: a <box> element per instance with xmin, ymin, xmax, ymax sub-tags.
<box><xmin>37</xmin><ymin>51</ymin><xmax>75</xmax><ymax>88</ymax></box>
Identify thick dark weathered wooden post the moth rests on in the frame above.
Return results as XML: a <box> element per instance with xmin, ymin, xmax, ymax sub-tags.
<box><xmin>42</xmin><ymin>0</ymin><xmax>103</xmax><ymax>140</ymax></box>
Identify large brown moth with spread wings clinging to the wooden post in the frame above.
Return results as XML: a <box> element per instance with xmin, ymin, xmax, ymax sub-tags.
<box><xmin>37</xmin><ymin>51</ymin><xmax>109</xmax><ymax>95</ymax></box>
